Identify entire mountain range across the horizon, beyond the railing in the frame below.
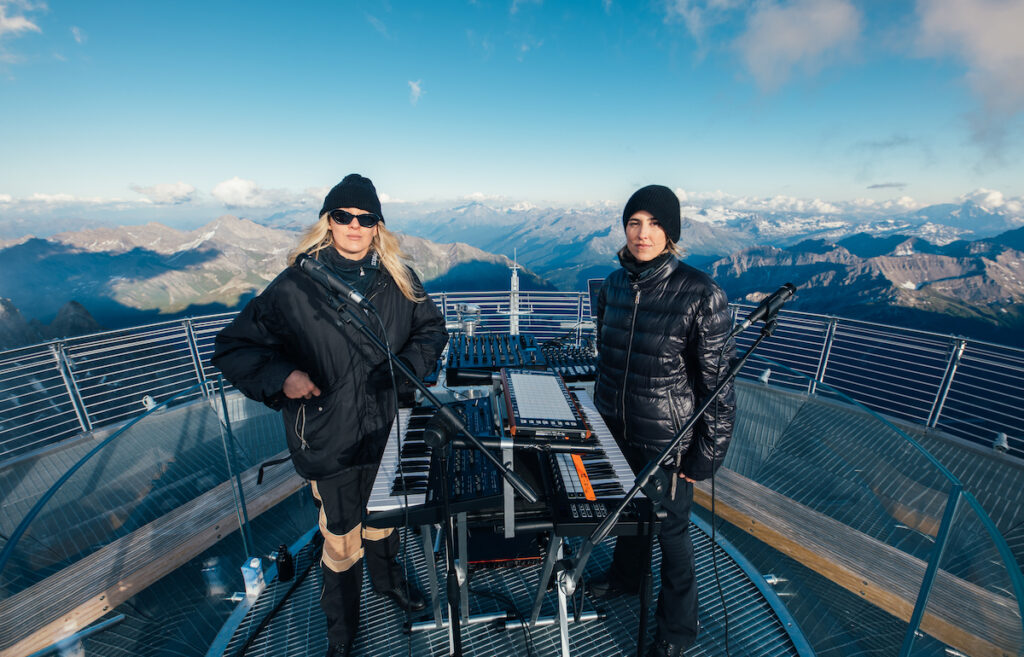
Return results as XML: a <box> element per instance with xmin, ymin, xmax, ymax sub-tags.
<box><xmin>0</xmin><ymin>196</ymin><xmax>1024</xmax><ymax>348</ymax></box>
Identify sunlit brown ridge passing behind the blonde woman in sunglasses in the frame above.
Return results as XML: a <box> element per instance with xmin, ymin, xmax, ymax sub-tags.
<box><xmin>0</xmin><ymin>215</ymin><xmax>553</xmax><ymax>348</ymax></box>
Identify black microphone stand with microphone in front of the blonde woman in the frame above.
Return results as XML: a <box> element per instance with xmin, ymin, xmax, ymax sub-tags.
<box><xmin>329</xmin><ymin>293</ymin><xmax>538</xmax><ymax>657</ymax></box>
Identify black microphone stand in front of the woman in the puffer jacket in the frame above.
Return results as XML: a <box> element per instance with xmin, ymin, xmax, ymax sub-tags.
<box><xmin>558</xmin><ymin>311</ymin><xmax>778</xmax><ymax>656</ymax></box>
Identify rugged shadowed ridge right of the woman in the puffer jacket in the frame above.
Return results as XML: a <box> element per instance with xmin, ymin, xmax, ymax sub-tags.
<box><xmin>709</xmin><ymin>229</ymin><xmax>1024</xmax><ymax>345</ymax></box>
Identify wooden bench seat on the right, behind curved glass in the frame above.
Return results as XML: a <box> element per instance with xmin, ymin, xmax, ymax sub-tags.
<box><xmin>694</xmin><ymin>468</ymin><xmax>1021</xmax><ymax>657</ymax></box>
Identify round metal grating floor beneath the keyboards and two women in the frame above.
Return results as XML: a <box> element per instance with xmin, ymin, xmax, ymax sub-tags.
<box><xmin>218</xmin><ymin>515</ymin><xmax>806</xmax><ymax>657</ymax></box>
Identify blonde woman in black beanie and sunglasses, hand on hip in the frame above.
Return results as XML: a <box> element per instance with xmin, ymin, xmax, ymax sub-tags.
<box><xmin>212</xmin><ymin>174</ymin><xmax>447</xmax><ymax>657</ymax></box>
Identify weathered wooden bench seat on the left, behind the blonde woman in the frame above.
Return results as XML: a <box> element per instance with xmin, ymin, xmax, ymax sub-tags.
<box><xmin>0</xmin><ymin>452</ymin><xmax>305</xmax><ymax>657</ymax></box>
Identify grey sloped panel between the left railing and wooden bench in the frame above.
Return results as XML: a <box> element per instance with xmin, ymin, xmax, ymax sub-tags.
<box><xmin>0</xmin><ymin>386</ymin><xmax>285</xmax><ymax>598</ymax></box>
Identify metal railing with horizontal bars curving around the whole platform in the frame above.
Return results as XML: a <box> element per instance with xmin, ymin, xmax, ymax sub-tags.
<box><xmin>0</xmin><ymin>292</ymin><xmax>1024</xmax><ymax>463</ymax></box>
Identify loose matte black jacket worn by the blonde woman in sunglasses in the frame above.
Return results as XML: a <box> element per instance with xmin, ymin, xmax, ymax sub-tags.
<box><xmin>211</xmin><ymin>255</ymin><xmax>447</xmax><ymax>479</ymax></box>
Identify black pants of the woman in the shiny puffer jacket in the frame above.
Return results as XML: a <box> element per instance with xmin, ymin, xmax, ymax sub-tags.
<box><xmin>605</xmin><ymin>419</ymin><xmax>697</xmax><ymax>647</ymax></box>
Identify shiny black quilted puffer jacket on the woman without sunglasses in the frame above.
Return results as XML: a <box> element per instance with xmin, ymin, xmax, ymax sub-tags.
<box><xmin>594</xmin><ymin>256</ymin><xmax>735</xmax><ymax>480</ymax></box>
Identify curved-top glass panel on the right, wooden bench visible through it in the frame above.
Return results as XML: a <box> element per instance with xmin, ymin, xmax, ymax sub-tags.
<box><xmin>701</xmin><ymin>356</ymin><xmax>983</xmax><ymax>657</ymax></box>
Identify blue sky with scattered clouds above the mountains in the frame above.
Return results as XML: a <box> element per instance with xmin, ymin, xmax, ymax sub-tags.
<box><xmin>0</xmin><ymin>0</ymin><xmax>1024</xmax><ymax>228</ymax></box>
